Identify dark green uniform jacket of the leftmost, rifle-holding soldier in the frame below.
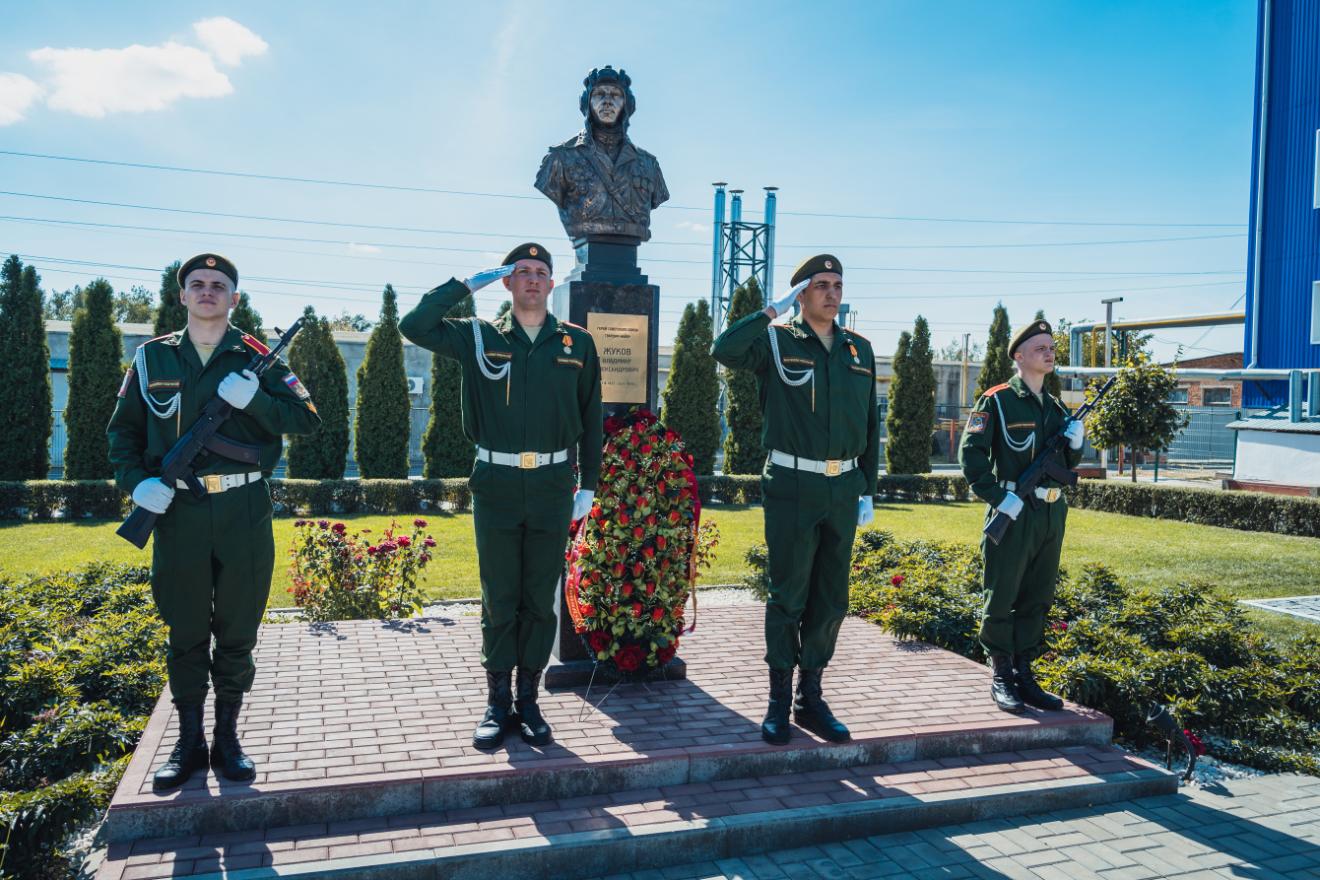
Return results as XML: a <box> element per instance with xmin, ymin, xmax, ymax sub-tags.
<box><xmin>106</xmin><ymin>325</ymin><xmax>321</xmax><ymax>492</ymax></box>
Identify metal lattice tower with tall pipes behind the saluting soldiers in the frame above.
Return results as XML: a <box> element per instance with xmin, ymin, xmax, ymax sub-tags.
<box><xmin>710</xmin><ymin>181</ymin><xmax>779</xmax><ymax>334</ymax></box>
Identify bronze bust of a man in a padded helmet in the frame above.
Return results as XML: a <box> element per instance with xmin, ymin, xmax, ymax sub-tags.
<box><xmin>536</xmin><ymin>66</ymin><xmax>669</xmax><ymax>244</ymax></box>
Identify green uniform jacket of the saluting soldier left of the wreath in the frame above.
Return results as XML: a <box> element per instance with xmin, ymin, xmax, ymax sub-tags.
<box><xmin>399</xmin><ymin>278</ymin><xmax>605</xmax><ymax>491</ymax></box>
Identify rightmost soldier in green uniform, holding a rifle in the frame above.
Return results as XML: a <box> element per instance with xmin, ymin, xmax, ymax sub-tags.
<box><xmin>958</xmin><ymin>321</ymin><xmax>1084</xmax><ymax>714</ymax></box>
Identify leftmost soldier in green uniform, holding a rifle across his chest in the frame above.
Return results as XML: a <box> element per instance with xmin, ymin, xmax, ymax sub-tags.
<box><xmin>107</xmin><ymin>253</ymin><xmax>321</xmax><ymax>790</ymax></box>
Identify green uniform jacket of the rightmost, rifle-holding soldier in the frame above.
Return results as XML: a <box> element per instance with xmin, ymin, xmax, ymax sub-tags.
<box><xmin>958</xmin><ymin>376</ymin><xmax>1081</xmax><ymax>507</ymax></box>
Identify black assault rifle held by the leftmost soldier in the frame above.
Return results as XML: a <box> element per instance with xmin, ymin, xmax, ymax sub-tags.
<box><xmin>115</xmin><ymin>318</ymin><xmax>302</xmax><ymax>549</ymax></box>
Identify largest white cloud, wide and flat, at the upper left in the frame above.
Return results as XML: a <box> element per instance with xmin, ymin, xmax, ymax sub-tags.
<box><xmin>28</xmin><ymin>42</ymin><xmax>234</xmax><ymax>119</ymax></box>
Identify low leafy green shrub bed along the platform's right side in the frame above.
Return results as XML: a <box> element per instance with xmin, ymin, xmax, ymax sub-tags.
<box><xmin>747</xmin><ymin>529</ymin><xmax>1320</xmax><ymax>776</ymax></box>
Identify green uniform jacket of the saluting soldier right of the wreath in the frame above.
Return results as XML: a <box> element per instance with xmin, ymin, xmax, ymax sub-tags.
<box><xmin>711</xmin><ymin>311</ymin><xmax>880</xmax><ymax>495</ymax></box>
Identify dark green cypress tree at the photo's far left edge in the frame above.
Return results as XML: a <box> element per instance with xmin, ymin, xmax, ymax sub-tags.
<box><xmin>0</xmin><ymin>256</ymin><xmax>51</xmax><ymax>480</ymax></box>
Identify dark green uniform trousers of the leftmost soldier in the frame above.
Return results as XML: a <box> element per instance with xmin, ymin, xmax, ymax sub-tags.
<box><xmin>152</xmin><ymin>480</ymin><xmax>275</xmax><ymax>705</ymax></box>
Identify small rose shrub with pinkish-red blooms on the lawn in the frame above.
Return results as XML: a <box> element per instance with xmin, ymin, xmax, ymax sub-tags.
<box><xmin>289</xmin><ymin>520</ymin><xmax>436</xmax><ymax>623</ymax></box>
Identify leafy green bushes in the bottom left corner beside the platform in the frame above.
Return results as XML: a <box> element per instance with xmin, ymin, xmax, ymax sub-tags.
<box><xmin>0</xmin><ymin>563</ymin><xmax>165</xmax><ymax>877</ymax></box>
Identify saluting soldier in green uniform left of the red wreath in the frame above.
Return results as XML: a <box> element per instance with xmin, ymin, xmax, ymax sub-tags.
<box><xmin>399</xmin><ymin>243</ymin><xmax>603</xmax><ymax>748</ymax></box>
